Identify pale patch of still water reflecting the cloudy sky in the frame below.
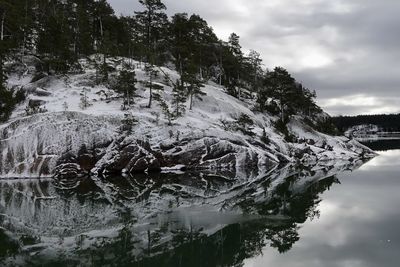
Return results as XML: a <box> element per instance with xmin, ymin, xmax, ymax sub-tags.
<box><xmin>244</xmin><ymin>150</ymin><xmax>400</xmax><ymax>267</ymax></box>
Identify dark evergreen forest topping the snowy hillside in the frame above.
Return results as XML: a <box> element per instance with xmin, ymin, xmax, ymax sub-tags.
<box><xmin>0</xmin><ymin>0</ymin><xmax>321</xmax><ymax>132</ymax></box>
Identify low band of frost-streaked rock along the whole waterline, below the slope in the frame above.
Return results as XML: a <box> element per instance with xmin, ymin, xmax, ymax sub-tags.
<box><xmin>0</xmin><ymin>112</ymin><xmax>372</xmax><ymax>178</ymax></box>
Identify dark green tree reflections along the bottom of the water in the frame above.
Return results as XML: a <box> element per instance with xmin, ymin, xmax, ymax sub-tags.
<box><xmin>49</xmin><ymin>176</ymin><xmax>338</xmax><ymax>267</ymax></box>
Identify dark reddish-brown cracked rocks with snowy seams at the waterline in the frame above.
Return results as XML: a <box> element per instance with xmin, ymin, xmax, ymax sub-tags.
<box><xmin>55</xmin><ymin>137</ymin><xmax>282</xmax><ymax>177</ymax></box>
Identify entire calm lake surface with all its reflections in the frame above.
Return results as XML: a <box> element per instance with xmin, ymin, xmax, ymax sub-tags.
<box><xmin>0</xmin><ymin>146</ymin><xmax>400</xmax><ymax>267</ymax></box>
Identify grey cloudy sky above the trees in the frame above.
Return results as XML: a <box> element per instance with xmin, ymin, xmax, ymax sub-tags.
<box><xmin>108</xmin><ymin>0</ymin><xmax>400</xmax><ymax>115</ymax></box>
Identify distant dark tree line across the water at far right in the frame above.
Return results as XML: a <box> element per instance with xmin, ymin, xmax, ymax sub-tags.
<box><xmin>332</xmin><ymin>114</ymin><xmax>400</xmax><ymax>132</ymax></box>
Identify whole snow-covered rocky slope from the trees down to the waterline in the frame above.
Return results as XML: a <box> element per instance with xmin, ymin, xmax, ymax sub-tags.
<box><xmin>0</xmin><ymin>58</ymin><xmax>374</xmax><ymax>178</ymax></box>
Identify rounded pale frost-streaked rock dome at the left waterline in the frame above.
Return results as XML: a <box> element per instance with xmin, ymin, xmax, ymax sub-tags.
<box><xmin>0</xmin><ymin>112</ymin><xmax>118</xmax><ymax>177</ymax></box>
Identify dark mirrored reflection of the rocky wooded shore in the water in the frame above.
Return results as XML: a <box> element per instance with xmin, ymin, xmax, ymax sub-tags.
<box><xmin>0</xmin><ymin>160</ymin><xmax>368</xmax><ymax>266</ymax></box>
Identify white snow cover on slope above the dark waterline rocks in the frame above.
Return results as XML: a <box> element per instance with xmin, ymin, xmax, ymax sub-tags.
<box><xmin>0</xmin><ymin>56</ymin><xmax>376</xmax><ymax>177</ymax></box>
